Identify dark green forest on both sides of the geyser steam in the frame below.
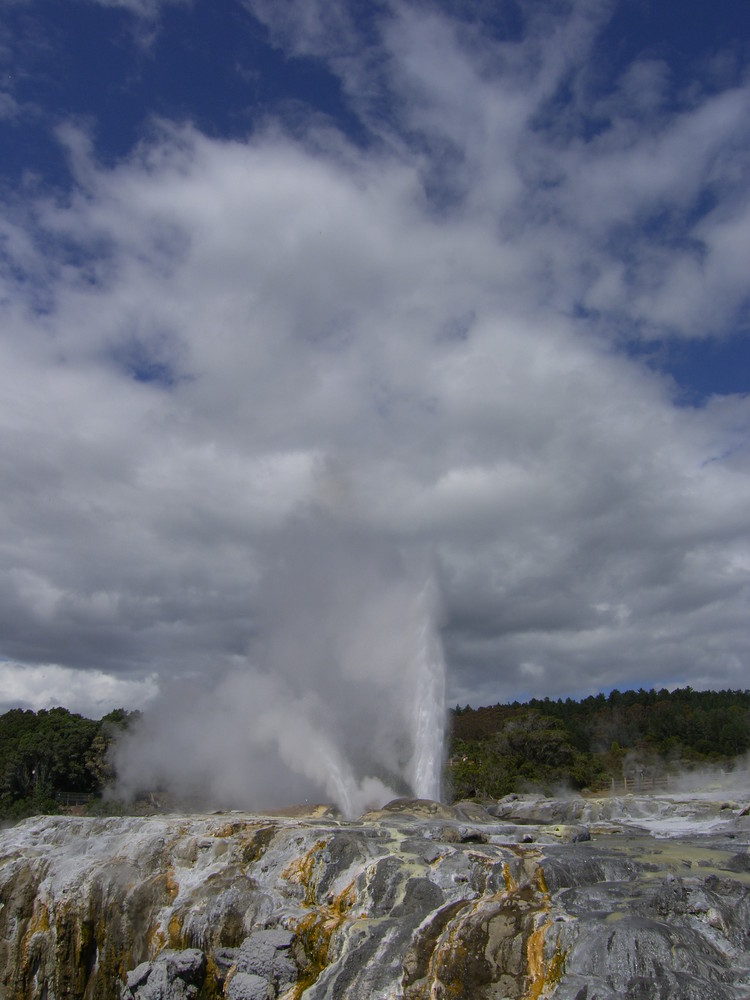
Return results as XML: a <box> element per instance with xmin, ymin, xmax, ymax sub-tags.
<box><xmin>0</xmin><ymin>687</ymin><xmax>750</xmax><ymax>820</ymax></box>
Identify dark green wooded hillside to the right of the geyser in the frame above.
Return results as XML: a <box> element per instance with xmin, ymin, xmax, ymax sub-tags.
<box><xmin>446</xmin><ymin>687</ymin><xmax>750</xmax><ymax>799</ymax></box>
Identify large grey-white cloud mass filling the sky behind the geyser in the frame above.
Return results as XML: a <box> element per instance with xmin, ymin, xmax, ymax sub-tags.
<box><xmin>0</xmin><ymin>4</ymin><xmax>750</xmax><ymax>764</ymax></box>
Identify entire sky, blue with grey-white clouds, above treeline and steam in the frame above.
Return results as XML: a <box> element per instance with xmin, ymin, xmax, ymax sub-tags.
<box><xmin>0</xmin><ymin>0</ymin><xmax>750</xmax><ymax>724</ymax></box>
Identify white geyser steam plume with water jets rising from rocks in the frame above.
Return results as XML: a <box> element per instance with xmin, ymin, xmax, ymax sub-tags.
<box><xmin>115</xmin><ymin>513</ymin><xmax>445</xmax><ymax>817</ymax></box>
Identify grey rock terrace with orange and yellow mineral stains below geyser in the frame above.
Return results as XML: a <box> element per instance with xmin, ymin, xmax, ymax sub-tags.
<box><xmin>0</xmin><ymin>796</ymin><xmax>750</xmax><ymax>1000</ymax></box>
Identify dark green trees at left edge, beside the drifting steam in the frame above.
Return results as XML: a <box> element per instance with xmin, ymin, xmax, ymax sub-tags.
<box><xmin>0</xmin><ymin>708</ymin><xmax>138</xmax><ymax>819</ymax></box>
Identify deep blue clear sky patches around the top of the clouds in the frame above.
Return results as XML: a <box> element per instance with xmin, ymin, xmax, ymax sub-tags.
<box><xmin>5</xmin><ymin>0</ymin><xmax>750</xmax><ymax>394</ymax></box>
